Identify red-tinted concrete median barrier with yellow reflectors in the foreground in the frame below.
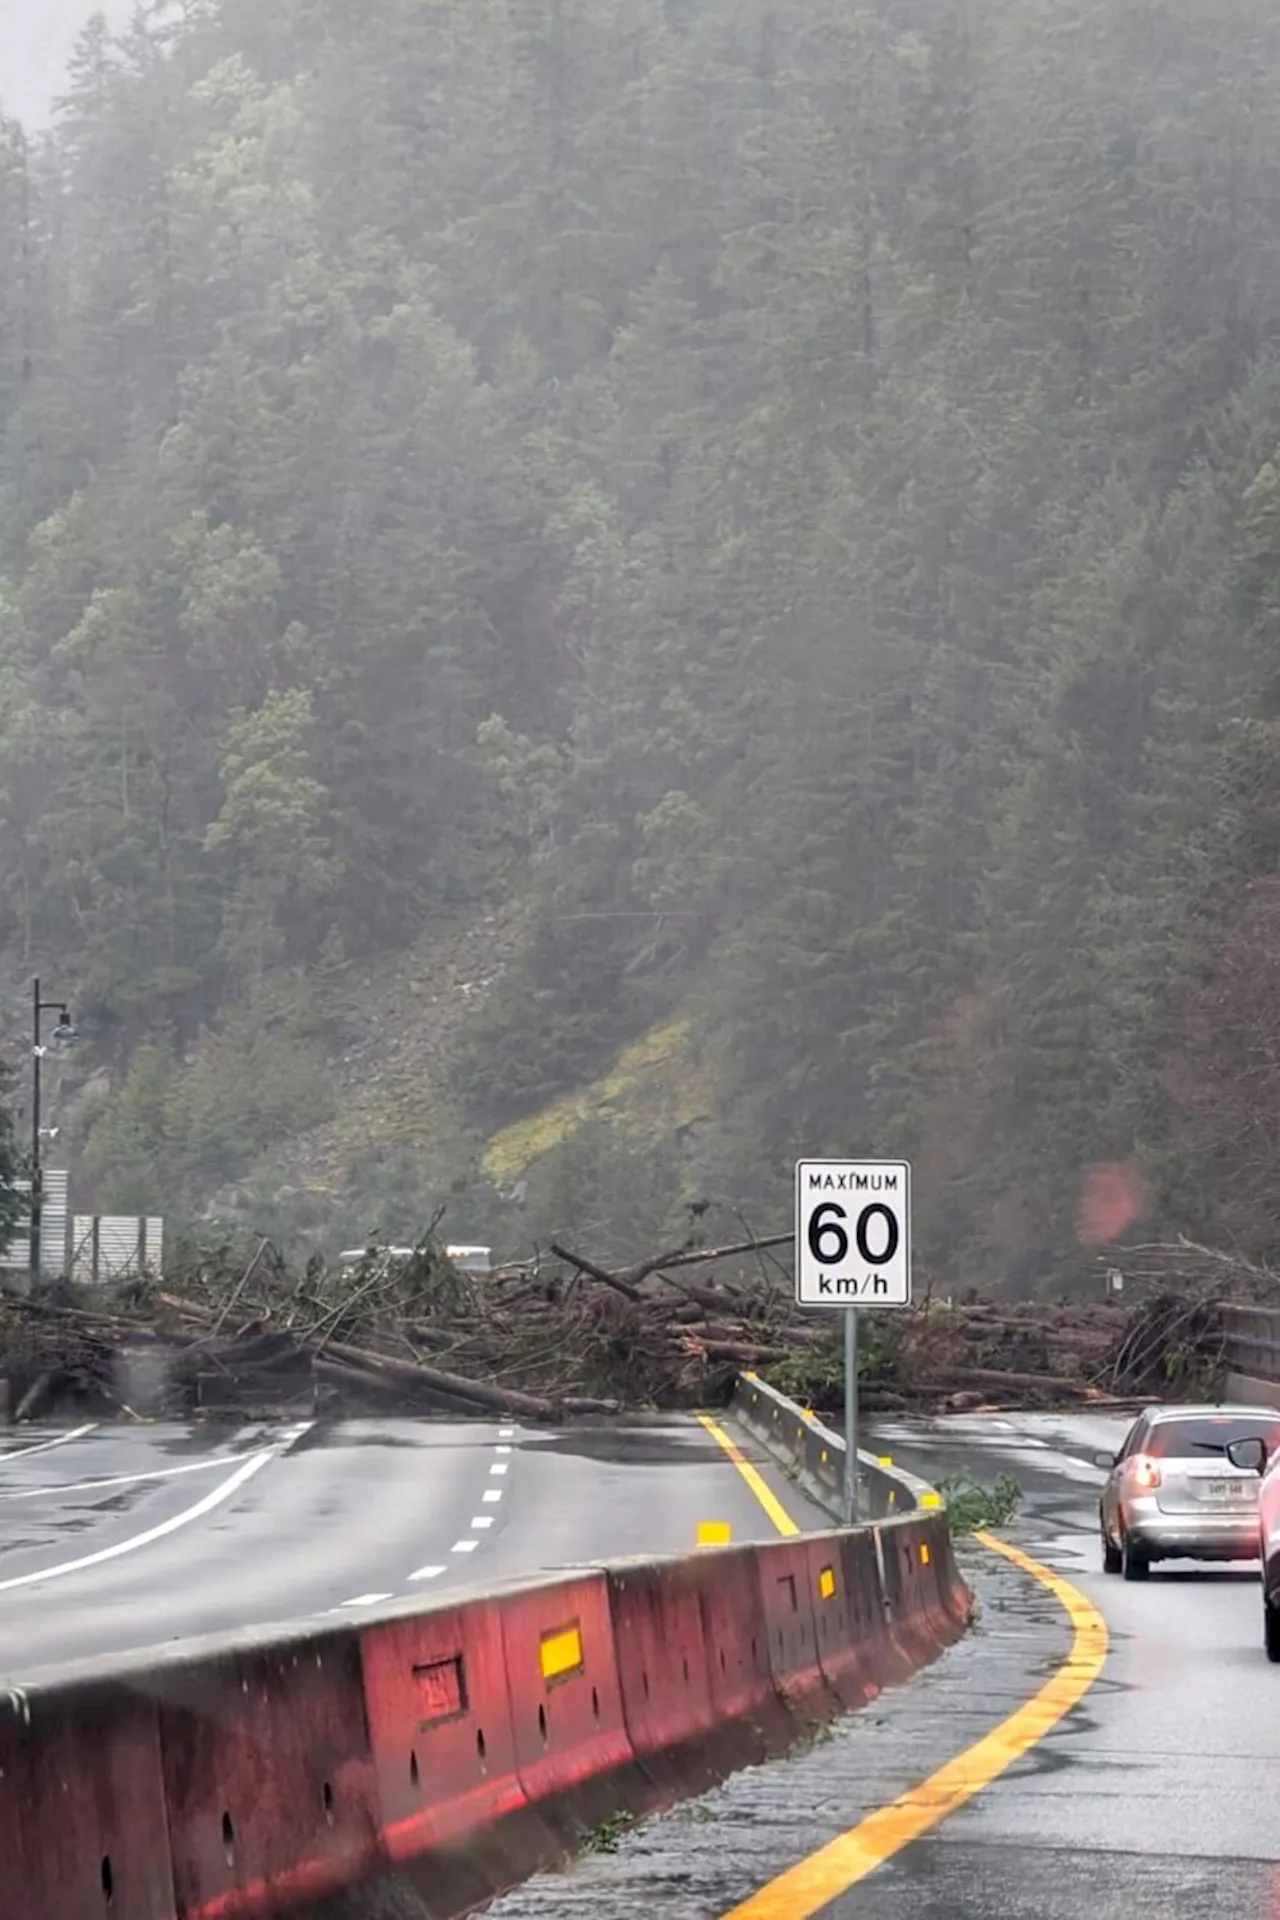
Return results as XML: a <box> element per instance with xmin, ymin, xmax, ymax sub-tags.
<box><xmin>0</xmin><ymin>1413</ymin><xmax>967</xmax><ymax>1920</ymax></box>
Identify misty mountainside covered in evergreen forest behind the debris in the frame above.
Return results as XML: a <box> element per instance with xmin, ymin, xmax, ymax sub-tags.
<box><xmin>0</xmin><ymin>0</ymin><xmax>1280</xmax><ymax>1286</ymax></box>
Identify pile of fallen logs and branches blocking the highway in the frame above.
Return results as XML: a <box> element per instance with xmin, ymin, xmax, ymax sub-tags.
<box><xmin>0</xmin><ymin>1229</ymin><xmax>1243</xmax><ymax>1421</ymax></box>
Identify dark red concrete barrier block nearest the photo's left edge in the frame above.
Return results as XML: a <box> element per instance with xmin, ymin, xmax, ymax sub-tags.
<box><xmin>0</xmin><ymin>1680</ymin><xmax>175</xmax><ymax>1920</ymax></box>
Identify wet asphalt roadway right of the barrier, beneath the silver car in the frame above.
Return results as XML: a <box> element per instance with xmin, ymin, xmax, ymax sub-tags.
<box><xmin>491</xmin><ymin>1415</ymin><xmax>1280</xmax><ymax>1920</ymax></box>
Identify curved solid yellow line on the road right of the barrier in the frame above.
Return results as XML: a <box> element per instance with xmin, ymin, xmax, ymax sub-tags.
<box><xmin>722</xmin><ymin>1532</ymin><xmax>1107</xmax><ymax>1920</ymax></box>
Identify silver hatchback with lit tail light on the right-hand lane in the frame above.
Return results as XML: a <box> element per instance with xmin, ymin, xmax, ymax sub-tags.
<box><xmin>1096</xmin><ymin>1405</ymin><xmax>1280</xmax><ymax>1580</ymax></box>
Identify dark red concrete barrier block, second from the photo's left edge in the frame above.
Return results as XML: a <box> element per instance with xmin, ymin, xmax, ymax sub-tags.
<box><xmin>160</xmin><ymin>1628</ymin><xmax>382</xmax><ymax>1920</ymax></box>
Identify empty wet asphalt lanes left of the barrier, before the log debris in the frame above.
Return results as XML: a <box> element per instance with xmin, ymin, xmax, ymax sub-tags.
<box><xmin>0</xmin><ymin>1419</ymin><xmax>821</xmax><ymax>1684</ymax></box>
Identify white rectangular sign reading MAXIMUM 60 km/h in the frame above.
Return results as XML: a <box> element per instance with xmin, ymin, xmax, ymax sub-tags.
<box><xmin>796</xmin><ymin>1160</ymin><xmax>912</xmax><ymax>1308</ymax></box>
